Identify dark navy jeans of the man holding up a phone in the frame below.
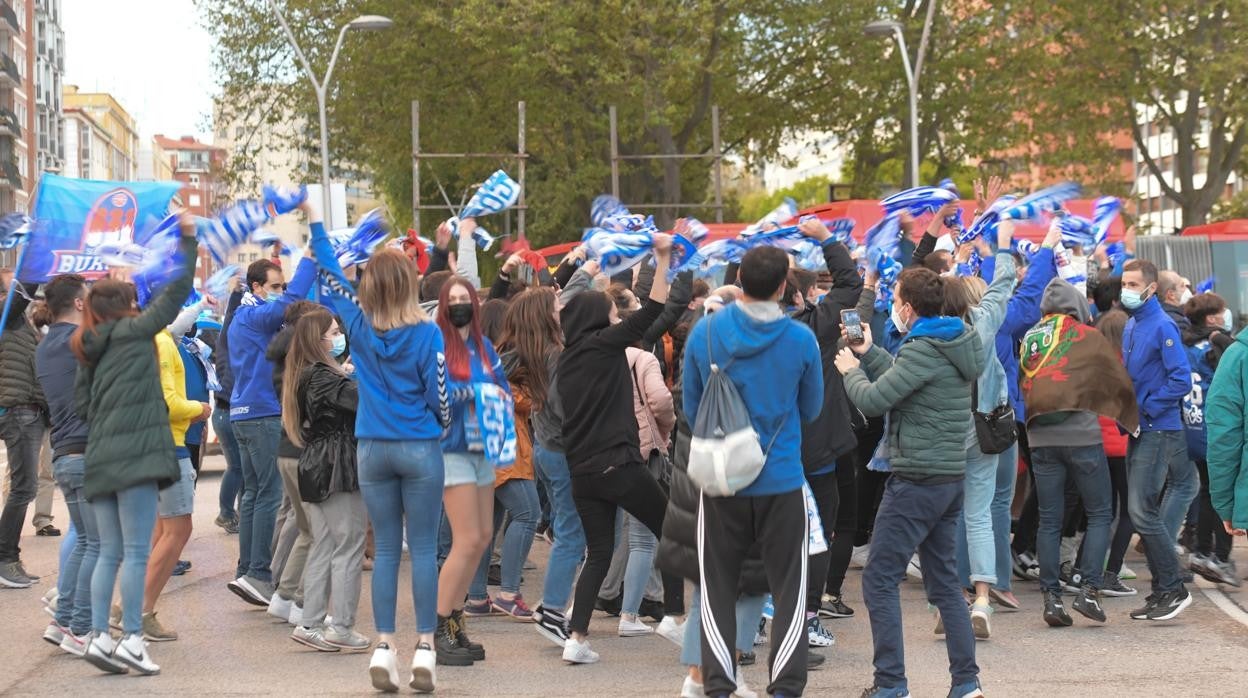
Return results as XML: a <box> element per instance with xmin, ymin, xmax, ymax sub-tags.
<box><xmin>862</xmin><ymin>474</ymin><xmax>980</xmax><ymax>689</ymax></box>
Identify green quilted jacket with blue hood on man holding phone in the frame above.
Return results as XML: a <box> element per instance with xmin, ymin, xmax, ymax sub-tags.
<box><xmin>845</xmin><ymin>317</ymin><xmax>983</xmax><ymax>477</ymax></box>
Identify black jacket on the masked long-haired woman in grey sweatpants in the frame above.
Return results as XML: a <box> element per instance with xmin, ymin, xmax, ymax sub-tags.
<box><xmin>298</xmin><ymin>363</ymin><xmax>359</xmax><ymax>503</ymax></box>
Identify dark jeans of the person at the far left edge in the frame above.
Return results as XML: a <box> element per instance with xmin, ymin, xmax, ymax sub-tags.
<box><xmin>0</xmin><ymin>407</ymin><xmax>44</xmax><ymax>562</ymax></box>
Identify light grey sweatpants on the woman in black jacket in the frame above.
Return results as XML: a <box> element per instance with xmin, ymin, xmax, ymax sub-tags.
<box><xmin>303</xmin><ymin>492</ymin><xmax>368</xmax><ymax>629</ymax></box>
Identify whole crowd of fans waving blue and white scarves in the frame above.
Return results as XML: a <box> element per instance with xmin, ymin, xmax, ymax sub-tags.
<box><xmin>0</xmin><ymin>181</ymin><xmax>1248</xmax><ymax>698</ymax></box>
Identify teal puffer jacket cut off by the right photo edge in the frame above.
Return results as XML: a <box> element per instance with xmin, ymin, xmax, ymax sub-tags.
<box><xmin>1204</xmin><ymin>331</ymin><xmax>1248</xmax><ymax>528</ymax></box>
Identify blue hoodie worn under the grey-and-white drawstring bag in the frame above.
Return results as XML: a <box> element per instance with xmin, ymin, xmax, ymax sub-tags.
<box><xmin>684</xmin><ymin>303</ymin><xmax>824</xmax><ymax>497</ymax></box>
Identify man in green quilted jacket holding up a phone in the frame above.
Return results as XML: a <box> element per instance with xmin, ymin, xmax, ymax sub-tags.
<box><xmin>836</xmin><ymin>267</ymin><xmax>985</xmax><ymax>698</ymax></box>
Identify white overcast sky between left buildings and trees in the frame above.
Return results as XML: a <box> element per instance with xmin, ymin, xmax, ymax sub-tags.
<box><xmin>61</xmin><ymin>0</ymin><xmax>216</xmax><ymax>140</ymax></box>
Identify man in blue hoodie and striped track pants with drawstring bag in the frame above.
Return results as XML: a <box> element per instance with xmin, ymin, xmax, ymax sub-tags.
<box><xmin>681</xmin><ymin>247</ymin><xmax>824</xmax><ymax>696</ymax></box>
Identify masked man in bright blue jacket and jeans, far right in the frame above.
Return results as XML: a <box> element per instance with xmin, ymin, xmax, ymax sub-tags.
<box><xmin>1122</xmin><ymin>260</ymin><xmax>1199</xmax><ymax>621</ymax></box>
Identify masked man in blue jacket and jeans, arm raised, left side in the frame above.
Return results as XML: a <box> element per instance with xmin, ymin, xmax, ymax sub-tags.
<box><xmin>227</xmin><ymin>237</ymin><xmax>316</xmax><ymax>607</ymax></box>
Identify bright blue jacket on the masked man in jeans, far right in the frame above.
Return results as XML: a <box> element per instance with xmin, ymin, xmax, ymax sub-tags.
<box><xmin>1122</xmin><ymin>296</ymin><xmax>1192</xmax><ymax>431</ymax></box>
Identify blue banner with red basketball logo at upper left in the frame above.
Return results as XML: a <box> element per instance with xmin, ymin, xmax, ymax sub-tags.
<box><xmin>19</xmin><ymin>174</ymin><xmax>182</xmax><ymax>283</ymax></box>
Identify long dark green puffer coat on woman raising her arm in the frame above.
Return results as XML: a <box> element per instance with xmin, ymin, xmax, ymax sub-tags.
<box><xmin>74</xmin><ymin>237</ymin><xmax>198</xmax><ymax>499</ymax></box>
